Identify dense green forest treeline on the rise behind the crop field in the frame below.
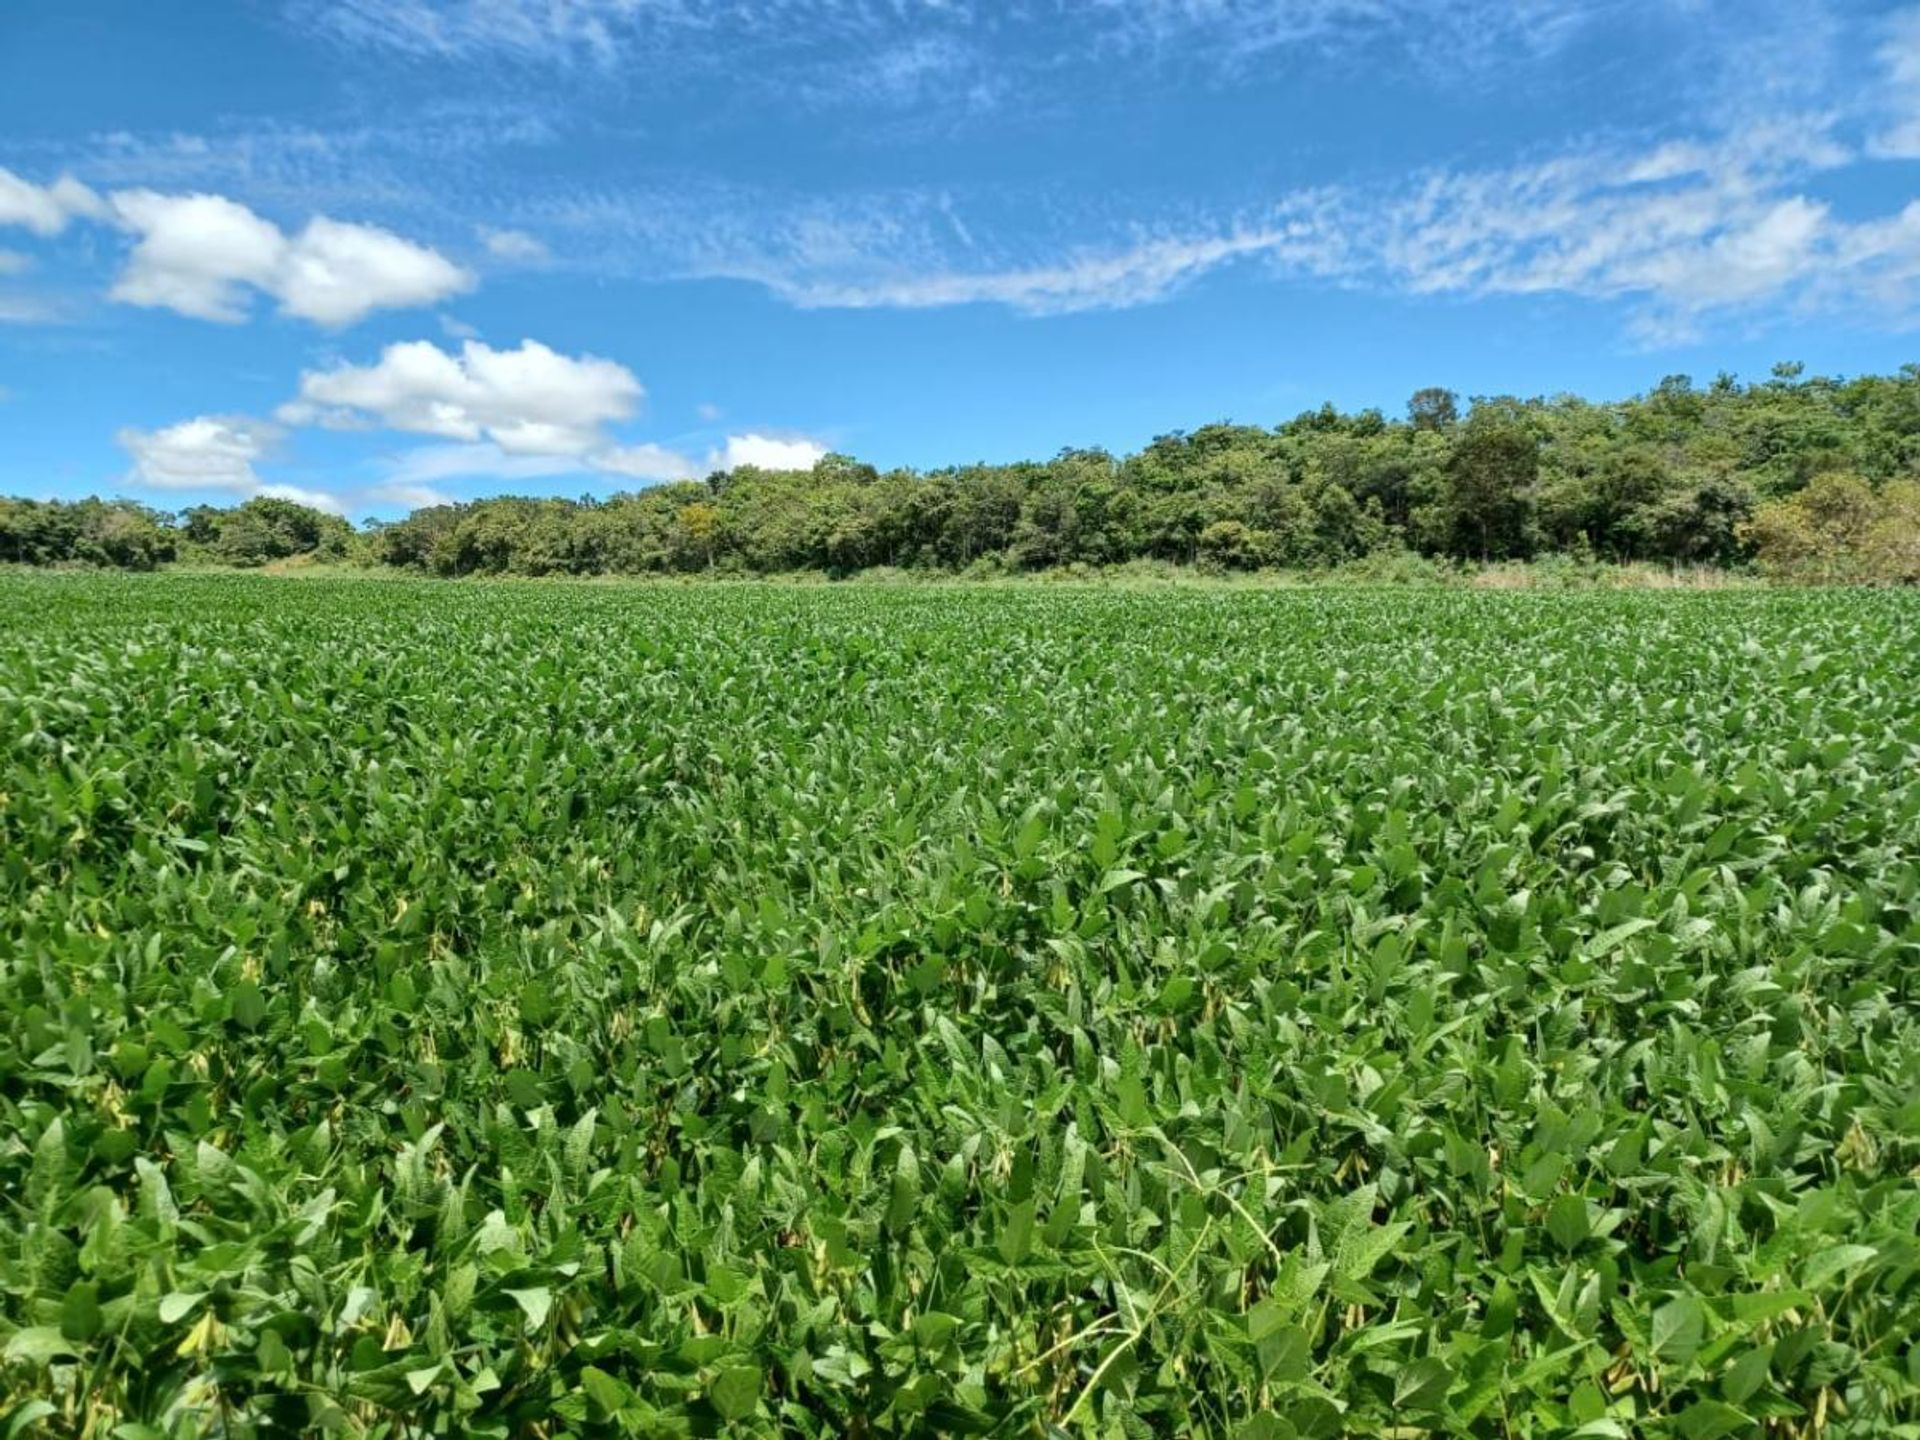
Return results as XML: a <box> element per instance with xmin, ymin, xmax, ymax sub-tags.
<box><xmin>11</xmin><ymin>365</ymin><xmax>1920</xmax><ymax>580</ymax></box>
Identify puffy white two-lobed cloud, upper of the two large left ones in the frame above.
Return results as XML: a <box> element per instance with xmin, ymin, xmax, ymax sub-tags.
<box><xmin>111</xmin><ymin>190</ymin><xmax>472</xmax><ymax>326</ymax></box>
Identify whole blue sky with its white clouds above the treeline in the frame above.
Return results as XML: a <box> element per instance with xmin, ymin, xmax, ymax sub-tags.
<box><xmin>0</xmin><ymin>0</ymin><xmax>1920</xmax><ymax>516</ymax></box>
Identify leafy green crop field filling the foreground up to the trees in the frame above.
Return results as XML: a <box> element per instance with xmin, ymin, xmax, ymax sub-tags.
<box><xmin>0</xmin><ymin>574</ymin><xmax>1920</xmax><ymax>1440</ymax></box>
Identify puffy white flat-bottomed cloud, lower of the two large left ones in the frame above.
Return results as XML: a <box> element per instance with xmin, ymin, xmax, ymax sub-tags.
<box><xmin>280</xmin><ymin>340</ymin><xmax>645</xmax><ymax>455</ymax></box>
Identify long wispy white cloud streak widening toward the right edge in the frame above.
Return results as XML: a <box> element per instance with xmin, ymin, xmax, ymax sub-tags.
<box><xmin>691</xmin><ymin>123</ymin><xmax>1920</xmax><ymax>338</ymax></box>
